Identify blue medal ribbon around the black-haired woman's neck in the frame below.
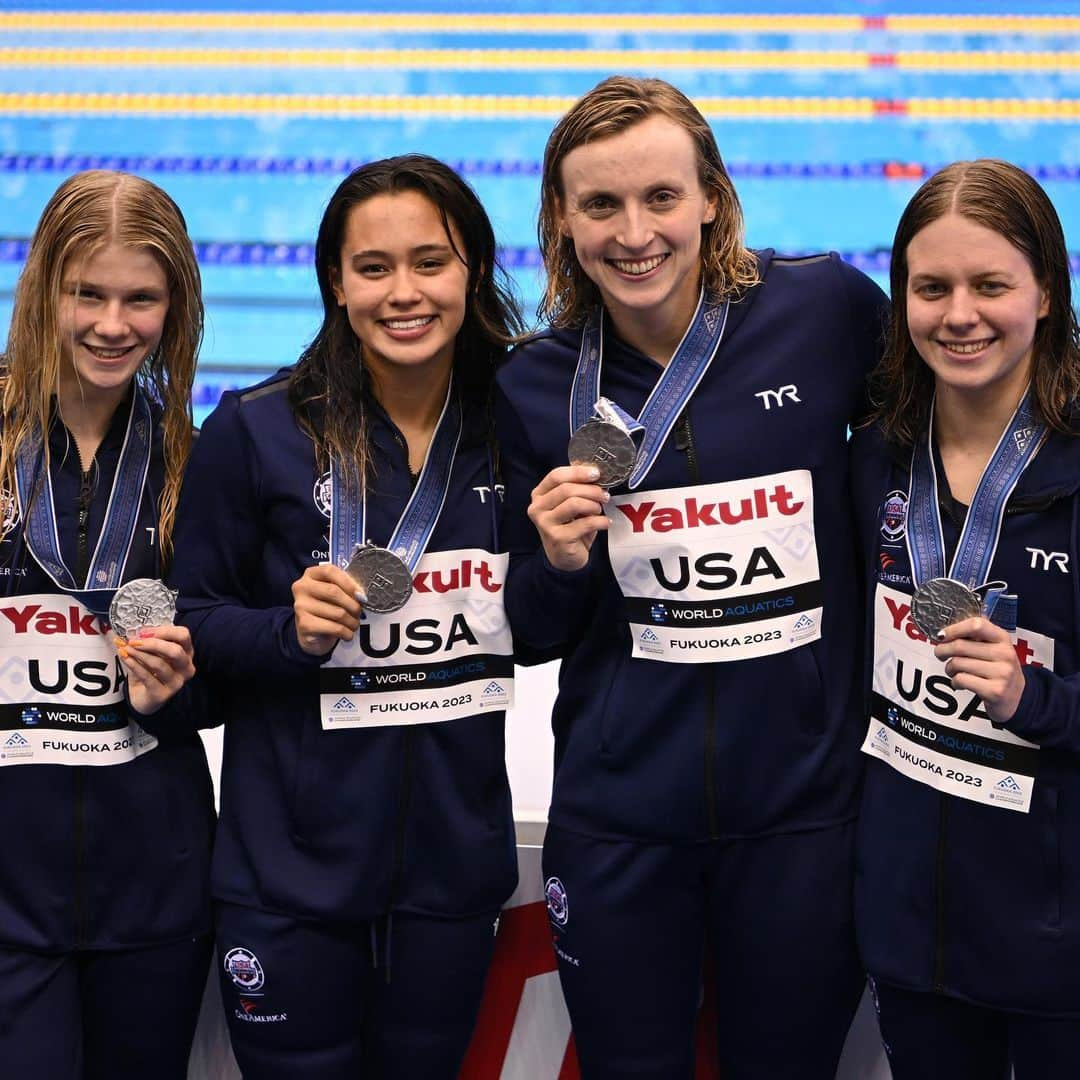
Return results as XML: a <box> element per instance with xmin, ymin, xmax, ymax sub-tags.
<box><xmin>330</xmin><ymin>378</ymin><xmax>462</xmax><ymax>573</ymax></box>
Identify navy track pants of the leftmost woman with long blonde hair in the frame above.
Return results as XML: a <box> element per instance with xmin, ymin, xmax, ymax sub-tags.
<box><xmin>0</xmin><ymin>937</ymin><xmax>212</xmax><ymax>1080</ymax></box>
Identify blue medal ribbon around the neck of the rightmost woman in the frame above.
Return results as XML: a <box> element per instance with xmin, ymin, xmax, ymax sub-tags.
<box><xmin>907</xmin><ymin>388</ymin><xmax>1048</xmax><ymax>621</ymax></box>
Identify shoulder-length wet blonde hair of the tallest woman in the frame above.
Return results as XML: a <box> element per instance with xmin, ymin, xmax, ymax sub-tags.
<box><xmin>537</xmin><ymin>75</ymin><xmax>760</xmax><ymax>326</ymax></box>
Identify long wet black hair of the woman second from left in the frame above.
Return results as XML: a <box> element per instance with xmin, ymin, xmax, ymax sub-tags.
<box><xmin>288</xmin><ymin>153</ymin><xmax>524</xmax><ymax>487</ymax></box>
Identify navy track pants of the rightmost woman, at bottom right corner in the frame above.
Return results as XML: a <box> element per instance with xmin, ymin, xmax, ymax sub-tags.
<box><xmin>874</xmin><ymin>980</ymin><xmax>1080</xmax><ymax>1080</ymax></box>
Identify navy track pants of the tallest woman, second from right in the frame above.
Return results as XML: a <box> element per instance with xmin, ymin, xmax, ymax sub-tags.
<box><xmin>543</xmin><ymin>825</ymin><xmax>865</xmax><ymax>1080</ymax></box>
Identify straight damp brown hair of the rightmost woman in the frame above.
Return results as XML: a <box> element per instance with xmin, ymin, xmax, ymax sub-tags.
<box><xmin>870</xmin><ymin>158</ymin><xmax>1080</xmax><ymax>446</ymax></box>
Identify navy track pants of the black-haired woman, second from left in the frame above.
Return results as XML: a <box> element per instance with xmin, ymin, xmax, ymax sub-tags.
<box><xmin>217</xmin><ymin>904</ymin><xmax>498</xmax><ymax>1080</ymax></box>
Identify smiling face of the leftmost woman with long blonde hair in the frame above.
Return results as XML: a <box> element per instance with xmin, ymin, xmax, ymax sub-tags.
<box><xmin>57</xmin><ymin>241</ymin><xmax>168</xmax><ymax>403</ymax></box>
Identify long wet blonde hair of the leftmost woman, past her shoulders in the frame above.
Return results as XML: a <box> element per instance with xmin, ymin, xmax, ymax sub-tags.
<box><xmin>0</xmin><ymin>170</ymin><xmax>203</xmax><ymax>563</ymax></box>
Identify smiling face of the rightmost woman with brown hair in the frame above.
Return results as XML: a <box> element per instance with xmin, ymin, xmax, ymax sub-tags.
<box><xmin>906</xmin><ymin>213</ymin><xmax>1049</xmax><ymax>405</ymax></box>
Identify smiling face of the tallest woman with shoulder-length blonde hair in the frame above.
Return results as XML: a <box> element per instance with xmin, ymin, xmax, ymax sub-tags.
<box><xmin>558</xmin><ymin>114</ymin><xmax>716</xmax><ymax>354</ymax></box>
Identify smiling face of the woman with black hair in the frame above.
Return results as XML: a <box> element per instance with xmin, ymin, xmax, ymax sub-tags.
<box><xmin>332</xmin><ymin>191</ymin><xmax>469</xmax><ymax>380</ymax></box>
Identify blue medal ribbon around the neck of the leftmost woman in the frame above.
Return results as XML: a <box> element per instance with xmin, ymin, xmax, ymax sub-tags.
<box><xmin>15</xmin><ymin>386</ymin><xmax>153</xmax><ymax>613</ymax></box>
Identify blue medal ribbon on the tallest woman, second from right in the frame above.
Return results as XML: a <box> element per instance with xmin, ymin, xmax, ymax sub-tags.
<box><xmin>570</xmin><ymin>289</ymin><xmax>730</xmax><ymax>490</ymax></box>
